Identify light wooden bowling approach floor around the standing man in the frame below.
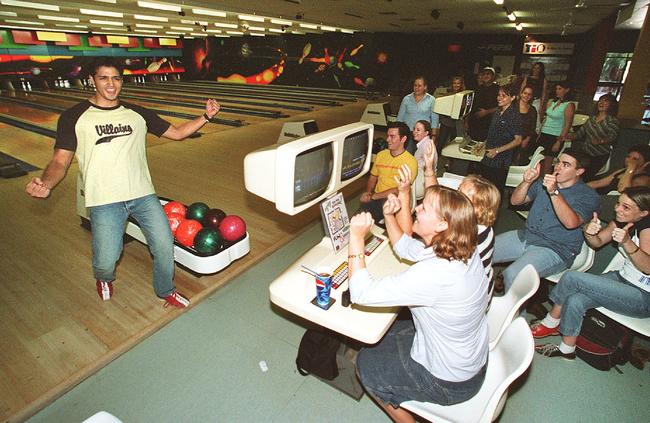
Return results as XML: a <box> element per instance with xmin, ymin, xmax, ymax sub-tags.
<box><xmin>0</xmin><ymin>97</ymin><xmax>372</xmax><ymax>421</ymax></box>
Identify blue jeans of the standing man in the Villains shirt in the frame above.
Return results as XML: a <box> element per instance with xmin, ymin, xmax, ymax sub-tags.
<box><xmin>89</xmin><ymin>194</ymin><xmax>174</xmax><ymax>298</ymax></box>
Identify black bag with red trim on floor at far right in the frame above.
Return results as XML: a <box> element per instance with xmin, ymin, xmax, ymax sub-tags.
<box><xmin>576</xmin><ymin>309</ymin><xmax>632</xmax><ymax>371</ymax></box>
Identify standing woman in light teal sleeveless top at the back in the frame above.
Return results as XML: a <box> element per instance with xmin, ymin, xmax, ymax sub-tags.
<box><xmin>537</xmin><ymin>81</ymin><xmax>576</xmax><ymax>174</ymax></box>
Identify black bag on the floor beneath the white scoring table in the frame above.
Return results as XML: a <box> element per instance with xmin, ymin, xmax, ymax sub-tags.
<box><xmin>296</xmin><ymin>329</ymin><xmax>341</xmax><ymax>380</ymax></box>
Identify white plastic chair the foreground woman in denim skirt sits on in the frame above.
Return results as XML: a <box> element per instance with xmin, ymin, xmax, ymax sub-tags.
<box><xmin>400</xmin><ymin>317</ymin><xmax>535</xmax><ymax>423</ymax></box>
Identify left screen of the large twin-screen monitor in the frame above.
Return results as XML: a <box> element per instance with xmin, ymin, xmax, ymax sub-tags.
<box><xmin>294</xmin><ymin>143</ymin><xmax>334</xmax><ymax>207</ymax></box>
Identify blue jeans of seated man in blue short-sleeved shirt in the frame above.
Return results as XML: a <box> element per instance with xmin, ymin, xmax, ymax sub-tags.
<box><xmin>492</xmin><ymin>231</ymin><xmax>568</xmax><ymax>292</ymax></box>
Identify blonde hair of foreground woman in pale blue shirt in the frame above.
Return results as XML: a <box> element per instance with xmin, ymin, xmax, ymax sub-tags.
<box><xmin>424</xmin><ymin>185</ymin><xmax>477</xmax><ymax>263</ymax></box>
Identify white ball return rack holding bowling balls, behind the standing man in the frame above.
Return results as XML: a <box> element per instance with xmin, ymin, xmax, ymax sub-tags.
<box><xmin>77</xmin><ymin>178</ymin><xmax>250</xmax><ymax>277</ymax></box>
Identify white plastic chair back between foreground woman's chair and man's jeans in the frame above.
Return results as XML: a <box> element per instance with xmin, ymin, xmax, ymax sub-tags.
<box><xmin>487</xmin><ymin>264</ymin><xmax>539</xmax><ymax>350</ymax></box>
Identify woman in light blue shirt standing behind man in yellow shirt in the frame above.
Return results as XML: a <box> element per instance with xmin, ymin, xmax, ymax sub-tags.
<box><xmin>397</xmin><ymin>76</ymin><xmax>438</xmax><ymax>154</ymax></box>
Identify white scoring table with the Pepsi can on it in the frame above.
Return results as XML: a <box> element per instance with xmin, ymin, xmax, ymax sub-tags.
<box><xmin>269</xmin><ymin>228</ymin><xmax>402</xmax><ymax>344</ymax></box>
